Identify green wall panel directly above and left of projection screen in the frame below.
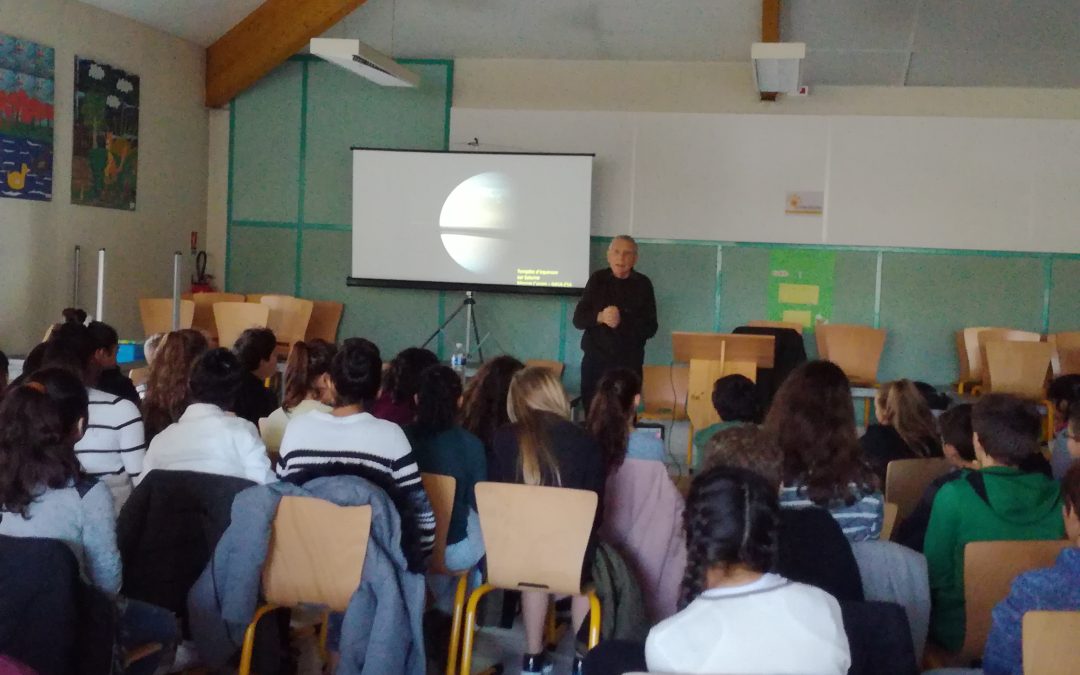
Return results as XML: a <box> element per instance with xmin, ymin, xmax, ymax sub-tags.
<box><xmin>303</xmin><ymin>62</ymin><xmax>454</xmax><ymax>226</ymax></box>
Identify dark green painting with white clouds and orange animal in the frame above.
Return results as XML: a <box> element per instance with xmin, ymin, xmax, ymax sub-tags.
<box><xmin>71</xmin><ymin>56</ymin><xmax>139</xmax><ymax>211</ymax></box>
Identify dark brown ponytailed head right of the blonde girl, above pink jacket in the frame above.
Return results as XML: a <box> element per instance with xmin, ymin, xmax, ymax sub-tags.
<box><xmin>585</xmin><ymin>368</ymin><xmax>642</xmax><ymax>471</ymax></box>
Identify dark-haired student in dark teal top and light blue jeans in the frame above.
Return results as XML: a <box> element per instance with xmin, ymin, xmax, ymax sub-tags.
<box><xmin>405</xmin><ymin>364</ymin><xmax>487</xmax><ymax>613</ymax></box>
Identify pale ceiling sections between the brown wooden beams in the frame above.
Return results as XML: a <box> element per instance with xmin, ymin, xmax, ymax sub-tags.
<box><xmin>76</xmin><ymin>0</ymin><xmax>1080</xmax><ymax>87</ymax></box>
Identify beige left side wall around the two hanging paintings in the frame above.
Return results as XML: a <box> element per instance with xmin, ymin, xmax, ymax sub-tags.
<box><xmin>0</xmin><ymin>0</ymin><xmax>207</xmax><ymax>353</ymax></box>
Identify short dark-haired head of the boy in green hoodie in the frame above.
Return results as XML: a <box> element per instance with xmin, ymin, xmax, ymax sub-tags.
<box><xmin>971</xmin><ymin>394</ymin><xmax>1042</xmax><ymax>467</ymax></box>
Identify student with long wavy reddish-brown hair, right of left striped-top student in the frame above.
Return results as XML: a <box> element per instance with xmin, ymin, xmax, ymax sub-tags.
<box><xmin>143</xmin><ymin>328</ymin><xmax>210</xmax><ymax>443</ymax></box>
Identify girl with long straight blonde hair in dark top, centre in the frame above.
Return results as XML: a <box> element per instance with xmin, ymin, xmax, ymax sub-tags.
<box><xmin>488</xmin><ymin>367</ymin><xmax>606</xmax><ymax>673</ymax></box>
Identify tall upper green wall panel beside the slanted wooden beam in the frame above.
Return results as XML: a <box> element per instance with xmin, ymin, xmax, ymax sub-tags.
<box><xmin>231</xmin><ymin>62</ymin><xmax>303</xmax><ymax>222</ymax></box>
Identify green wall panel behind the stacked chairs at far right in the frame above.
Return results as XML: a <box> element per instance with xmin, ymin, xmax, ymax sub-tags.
<box><xmin>878</xmin><ymin>253</ymin><xmax>1043</xmax><ymax>384</ymax></box>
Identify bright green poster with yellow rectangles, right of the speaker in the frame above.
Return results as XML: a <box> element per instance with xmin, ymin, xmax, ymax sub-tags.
<box><xmin>768</xmin><ymin>248</ymin><xmax>836</xmax><ymax>330</ymax></box>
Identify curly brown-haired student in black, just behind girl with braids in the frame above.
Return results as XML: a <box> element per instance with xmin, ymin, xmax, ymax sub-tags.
<box><xmin>702</xmin><ymin>426</ymin><xmax>864</xmax><ymax>602</ymax></box>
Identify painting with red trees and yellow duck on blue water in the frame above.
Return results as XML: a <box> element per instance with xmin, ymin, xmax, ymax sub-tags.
<box><xmin>0</xmin><ymin>33</ymin><xmax>55</xmax><ymax>201</ymax></box>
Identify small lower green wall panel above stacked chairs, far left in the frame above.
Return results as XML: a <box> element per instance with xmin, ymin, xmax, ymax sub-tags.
<box><xmin>229</xmin><ymin>225</ymin><xmax>296</xmax><ymax>295</ymax></box>
